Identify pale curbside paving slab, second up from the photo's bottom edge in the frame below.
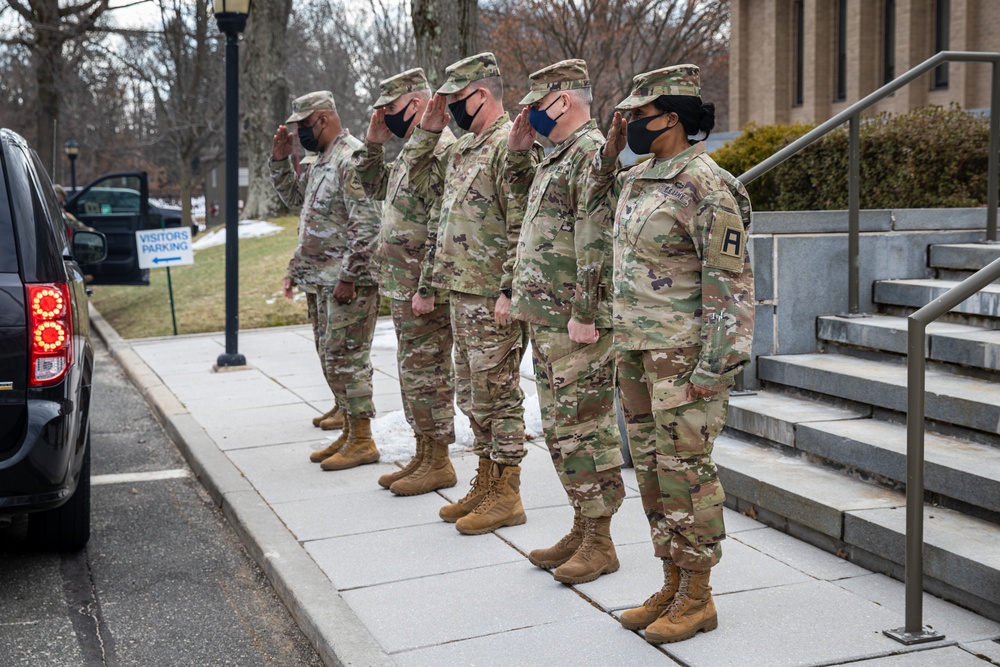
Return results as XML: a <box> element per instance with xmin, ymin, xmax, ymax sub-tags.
<box><xmin>342</xmin><ymin>560</ymin><xmax>616</xmax><ymax>654</ymax></box>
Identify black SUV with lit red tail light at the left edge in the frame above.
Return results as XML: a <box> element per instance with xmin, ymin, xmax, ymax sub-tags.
<box><xmin>0</xmin><ymin>129</ymin><xmax>107</xmax><ymax>550</ymax></box>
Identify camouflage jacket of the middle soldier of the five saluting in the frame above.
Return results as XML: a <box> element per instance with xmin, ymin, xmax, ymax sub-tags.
<box><xmin>410</xmin><ymin>113</ymin><xmax>541</xmax><ymax>296</ymax></box>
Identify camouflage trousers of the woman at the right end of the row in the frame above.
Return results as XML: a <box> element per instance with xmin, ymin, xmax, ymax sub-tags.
<box><xmin>617</xmin><ymin>348</ymin><xmax>729</xmax><ymax>571</ymax></box>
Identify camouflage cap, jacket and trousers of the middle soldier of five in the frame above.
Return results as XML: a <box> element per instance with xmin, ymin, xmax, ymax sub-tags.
<box><xmin>410</xmin><ymin>54</ymin><xmax>537</xmax><ymax>465</ymax></box>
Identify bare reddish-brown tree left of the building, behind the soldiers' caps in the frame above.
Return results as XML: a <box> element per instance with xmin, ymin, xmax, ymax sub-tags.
<box><xmin>482</xmin><ymin>0</ymin><xmax>729</xmax><ymax>130</ymax></box>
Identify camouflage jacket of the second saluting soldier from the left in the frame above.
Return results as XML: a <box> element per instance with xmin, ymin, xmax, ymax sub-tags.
<box><xmin>354</xmin><ymin>128</ymin><xmax>455</xmax><ymax>300</ymax></box>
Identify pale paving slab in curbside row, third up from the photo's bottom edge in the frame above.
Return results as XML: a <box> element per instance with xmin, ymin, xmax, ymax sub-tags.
<box><xmin>306</xmin><ymin>521</ymin><xmax>524</xmax><ymax>591</ymax></box>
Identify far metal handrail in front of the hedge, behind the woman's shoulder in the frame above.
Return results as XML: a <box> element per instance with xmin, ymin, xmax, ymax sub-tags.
<box><xmin>739</xmin><ymin>51</ymin><xmax>1000</xmax><ymax>315</ymax></box>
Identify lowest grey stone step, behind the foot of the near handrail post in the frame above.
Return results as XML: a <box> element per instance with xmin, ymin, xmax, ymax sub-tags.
<box><xmin>714</xmin><ymin>433</ymin><xmax>1000</xmax><ymax>620</ymax></box>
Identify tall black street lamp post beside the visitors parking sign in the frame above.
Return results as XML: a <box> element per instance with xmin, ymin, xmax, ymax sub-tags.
<box><xmin>213</xmin><ymin>0</ymin><xmax>250</xmax><ymax>368</ymax></box>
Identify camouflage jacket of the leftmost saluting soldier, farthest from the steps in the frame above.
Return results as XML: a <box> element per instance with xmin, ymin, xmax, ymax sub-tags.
<box><xmin>269</xmin><ymin>130</ymin><xmax>380</xmax><ymax>286</ymax></box>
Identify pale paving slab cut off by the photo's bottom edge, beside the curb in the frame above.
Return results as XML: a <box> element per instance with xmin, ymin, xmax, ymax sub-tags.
<box><xmin>393</xmin><ymin>617</ymin><xmax>679</xmax><ymax>667</ymax></box>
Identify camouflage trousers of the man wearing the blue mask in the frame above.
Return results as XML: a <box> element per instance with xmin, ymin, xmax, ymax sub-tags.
<box><xmin>529</xmin><ymin>324</ymin><xmax>625</xmax><ymax>519</ymax></box>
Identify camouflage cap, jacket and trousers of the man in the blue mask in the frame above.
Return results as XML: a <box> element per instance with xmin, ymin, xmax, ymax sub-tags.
<box><xmin>506</xmin><ymin>60</ymin><xmax>625</xmax><ymax>518</ymax></box>
